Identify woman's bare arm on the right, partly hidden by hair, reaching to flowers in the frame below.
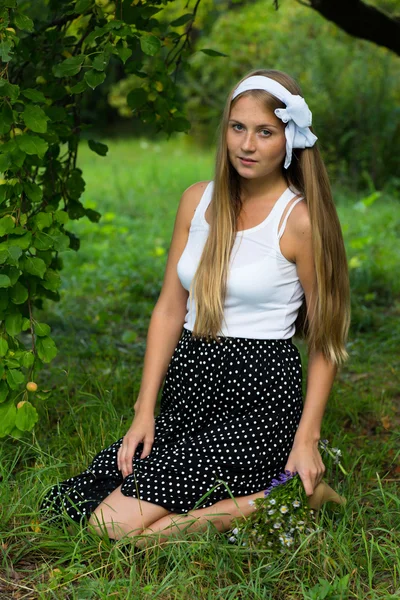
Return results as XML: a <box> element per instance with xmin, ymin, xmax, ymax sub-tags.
<box><xmin>281</xmin><ymin>202</ymin><xmax>337</xmax><ymax>496</ymax></box>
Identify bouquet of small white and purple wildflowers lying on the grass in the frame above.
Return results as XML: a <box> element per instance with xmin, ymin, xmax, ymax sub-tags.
<box><xmin>229</xmin><ymin>440</ymin><xmax>347</xmax><ymax>553</ymax></box>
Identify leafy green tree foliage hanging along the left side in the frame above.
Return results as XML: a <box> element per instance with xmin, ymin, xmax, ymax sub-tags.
<box><xmin>0</xmin><ymin>0</ymin><xmax>217</xmax><ymax>437</ymax></box>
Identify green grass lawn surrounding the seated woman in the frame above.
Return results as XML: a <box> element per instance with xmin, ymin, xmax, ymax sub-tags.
<box><xmin>0</xmin><ymin>139</ymin><xmax>400</xmax><ymax>600</ymax></box>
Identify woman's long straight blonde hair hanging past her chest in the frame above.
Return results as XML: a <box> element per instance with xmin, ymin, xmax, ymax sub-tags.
<box><xmin>190</xmin><ymin>69</ymin><xmax>350</xmax><ymax>364</ymax></box>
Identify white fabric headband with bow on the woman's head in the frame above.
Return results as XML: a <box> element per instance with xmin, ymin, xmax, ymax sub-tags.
<box><xmin>232</xmin><ymin>75</ymin><xmax>318</xmax><ymax>169</ymax></box>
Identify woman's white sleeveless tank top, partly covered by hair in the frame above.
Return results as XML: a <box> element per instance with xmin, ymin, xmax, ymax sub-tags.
<box><xmin>177</xmin><ymin>181</ymin><xmax>304</xmax><ymax>339</ymax></box>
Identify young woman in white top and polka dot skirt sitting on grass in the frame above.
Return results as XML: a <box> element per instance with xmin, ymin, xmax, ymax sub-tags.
<box><xmin>43</xmin><ymin>70</ymin><xmax>350</xmax><ymax>545</ymax></box>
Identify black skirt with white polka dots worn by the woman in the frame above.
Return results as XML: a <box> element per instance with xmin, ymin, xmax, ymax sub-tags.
<box><xmin>42</xmin><ymin>328</ymin><xmax>303</xmax><ymax>521</ymax></box>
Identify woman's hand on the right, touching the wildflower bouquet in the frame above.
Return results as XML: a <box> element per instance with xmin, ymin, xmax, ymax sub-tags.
<box><xmin>285</xmin><ymin>441</ymin><xmax>326</xmax><ymax>496</ymax></box>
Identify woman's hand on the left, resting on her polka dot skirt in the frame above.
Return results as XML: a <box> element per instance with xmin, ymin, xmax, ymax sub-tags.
<box><xmin>117</xmin><ymin>412</ymin><xmax>155</xmax><ymax>479</ymax></box>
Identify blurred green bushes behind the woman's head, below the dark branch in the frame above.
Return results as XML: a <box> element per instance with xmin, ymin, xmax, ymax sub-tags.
<box><xmin>185</xmin><ymin>0</ymin><xmax>400</xmax><ymax>189</ymax></box>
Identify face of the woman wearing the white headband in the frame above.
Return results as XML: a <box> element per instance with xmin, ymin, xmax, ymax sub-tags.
<box><xmin>226</xmin><ymin>96</ymin><xmax>286</xmax><ymax>179</ymax></box>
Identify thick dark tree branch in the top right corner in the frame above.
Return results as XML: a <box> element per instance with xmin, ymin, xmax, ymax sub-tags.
<box><xmin>298</xmin><ymin>0</ymin><xmax>400</xmax><ymax>55</ymax></box>
